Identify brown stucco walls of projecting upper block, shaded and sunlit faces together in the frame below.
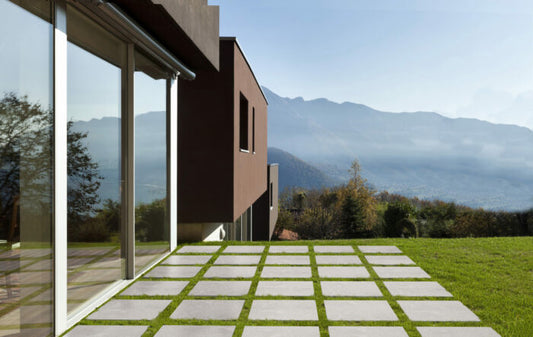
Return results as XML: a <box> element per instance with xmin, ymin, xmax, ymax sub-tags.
<box><xmin>178</xmin><ymin>39</ymin><xmax>267</xmax><ymax>223</ymax></box>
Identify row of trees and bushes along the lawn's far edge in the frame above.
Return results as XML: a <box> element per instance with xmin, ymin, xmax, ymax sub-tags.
<box><xmin>276</xmin><ymin>161</ymin><xmax>533</xmax><ymax>239</ymax></box>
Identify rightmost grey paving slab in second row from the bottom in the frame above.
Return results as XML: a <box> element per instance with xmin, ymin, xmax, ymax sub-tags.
<box><xmin>398</xmin><ymin>301</ymin><xmax>479</xmax><ymax>322</ymax></box>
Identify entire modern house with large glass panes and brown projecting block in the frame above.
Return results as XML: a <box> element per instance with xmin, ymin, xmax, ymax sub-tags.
<box><xmin>0</xmin><ymin>0</ymin><xmax>277</xmax><ymax>337</ymax></box>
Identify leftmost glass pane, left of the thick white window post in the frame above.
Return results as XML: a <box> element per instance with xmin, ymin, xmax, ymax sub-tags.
<box><xmin>0</xmin><ymin>0</ymin><xmax>53</xmax><ymax>337</ymax></box>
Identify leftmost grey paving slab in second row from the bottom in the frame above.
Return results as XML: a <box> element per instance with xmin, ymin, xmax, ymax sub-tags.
<box><xmin>88</xmin><ymin>300</ymin><xmax>171</xmax><ymax>320</ymax></box>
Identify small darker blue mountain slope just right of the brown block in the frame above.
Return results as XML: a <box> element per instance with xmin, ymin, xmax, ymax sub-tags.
<box><xmin>268</xmin><ymin>147</ymin><xmax>338</xmax><ymax>191</ymax></box>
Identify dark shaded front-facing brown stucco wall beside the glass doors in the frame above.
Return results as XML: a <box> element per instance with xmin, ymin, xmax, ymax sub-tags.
<box><xmin>178</xmin><ymin>43</ymin><xmax>234</xmax><ymax>223</ymax></box>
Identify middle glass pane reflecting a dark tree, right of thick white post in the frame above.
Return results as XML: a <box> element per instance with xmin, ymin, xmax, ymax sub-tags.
<box><xmin>67</xmin><ymin>7</ymin><xmax>125</xmax><ymax>313</ymax></box>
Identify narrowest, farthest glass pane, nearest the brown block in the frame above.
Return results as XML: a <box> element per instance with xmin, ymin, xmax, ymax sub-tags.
<box><xmin>134</xmin><ymin>53</ymin><xmax>169</xmax><ymax>271</ymax></box>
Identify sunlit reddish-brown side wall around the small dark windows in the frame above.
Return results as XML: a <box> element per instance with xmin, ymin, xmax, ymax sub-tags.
<box><xmin>232</xmin><ymin>39</ymin><xmax>267</xmax><ymax>217</ymax></box>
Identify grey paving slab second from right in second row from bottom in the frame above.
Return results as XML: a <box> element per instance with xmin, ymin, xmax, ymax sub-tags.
<box><xmin>324</xmin><ymin>300</ymin><xmax>398</xmax><ymax>321</ymax></box>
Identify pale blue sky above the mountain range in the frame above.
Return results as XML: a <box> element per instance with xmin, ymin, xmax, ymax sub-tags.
<box><xmin>209</xmin><ymin>0</ymin><xmax>533</xmax><ymax>129</ymax></box>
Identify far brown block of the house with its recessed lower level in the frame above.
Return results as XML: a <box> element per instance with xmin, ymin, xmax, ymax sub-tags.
<box><xmin>178</xmin><ymin>38</ymin><xmax>277</xmax><ymax>241</ymax></box>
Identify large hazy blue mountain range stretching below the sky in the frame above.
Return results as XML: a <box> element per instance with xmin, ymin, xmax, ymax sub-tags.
<box><xmin>263</xmin><ymin>88</ymin><xmax>533</xmax><ymax>210</ymax></box>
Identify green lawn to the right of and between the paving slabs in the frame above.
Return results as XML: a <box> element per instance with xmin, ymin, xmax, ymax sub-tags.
<box><xmin>72</xmin><ymin>237</ymin><xmax>533</xmax><ymax>337</ymax></box>
